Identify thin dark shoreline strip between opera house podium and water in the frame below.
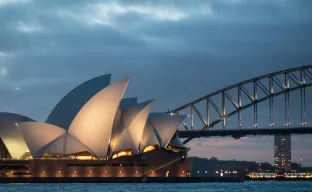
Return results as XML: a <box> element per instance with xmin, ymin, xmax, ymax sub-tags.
<box><xmin>0</xmin><ymin>177</ymin><xmax>245</xmax><ymax>184</ymax></box>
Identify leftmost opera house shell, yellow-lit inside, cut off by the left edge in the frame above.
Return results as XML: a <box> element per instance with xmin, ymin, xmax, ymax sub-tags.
<box><xmin>0</xmin><ymin>113</ymin><xmax>34</xmax><ymax>159</ymax></box>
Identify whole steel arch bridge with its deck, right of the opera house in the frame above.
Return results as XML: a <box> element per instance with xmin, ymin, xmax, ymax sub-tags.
<box><xmin>169</xmin><ymin>65</ymin><xmax>312</xmax><ymax>144</ymax></box>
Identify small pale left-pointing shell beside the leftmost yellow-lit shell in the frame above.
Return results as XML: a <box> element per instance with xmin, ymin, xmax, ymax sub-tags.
<box><xmin>17</xmin><ymin>122</ymin><xmax>66</xmax><ymax>158</ymax></box>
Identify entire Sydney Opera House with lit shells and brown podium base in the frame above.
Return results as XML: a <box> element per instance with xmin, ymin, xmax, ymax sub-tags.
<box><xmin>0</xmin><ymin>75</ymin><xmax>191</xmax><ymax>178</ymax></box>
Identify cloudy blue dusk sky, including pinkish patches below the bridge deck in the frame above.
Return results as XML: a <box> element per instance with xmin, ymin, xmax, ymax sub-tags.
<box><xmin>0</xmin><ymin>0</ymin><xmax>312</xmax><ymax>165</ymax></box>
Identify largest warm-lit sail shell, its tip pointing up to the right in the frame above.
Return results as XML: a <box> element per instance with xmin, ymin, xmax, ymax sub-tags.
<box><xmin>69</xmin><ymin>78</ymin><xmax>130</xmax><ymax>157</ymax></box>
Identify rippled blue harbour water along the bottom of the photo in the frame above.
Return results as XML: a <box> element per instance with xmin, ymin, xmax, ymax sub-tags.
<box><xmin>0</xmin><ymin>181</ymin><xmax>312</xmax><ymax>192</ymax></box>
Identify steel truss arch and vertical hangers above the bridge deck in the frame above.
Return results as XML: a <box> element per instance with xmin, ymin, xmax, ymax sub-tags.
<box><xmin>170</xmin><ymin>65</ymin><xmax>312</xmax><ymax>143</ymax></box>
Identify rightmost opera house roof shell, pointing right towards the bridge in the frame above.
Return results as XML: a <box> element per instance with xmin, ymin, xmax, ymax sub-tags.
<box><xmin>149</xmin><ymin>113</ymin><xmax>187</xmax><ymax>148</ymax></box>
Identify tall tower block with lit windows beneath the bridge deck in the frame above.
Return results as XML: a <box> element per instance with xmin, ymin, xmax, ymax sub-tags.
<box><xmin>274</xmin><ymin>135</ymin><xmax>291</xmax><ymax>170</ymax></box>
